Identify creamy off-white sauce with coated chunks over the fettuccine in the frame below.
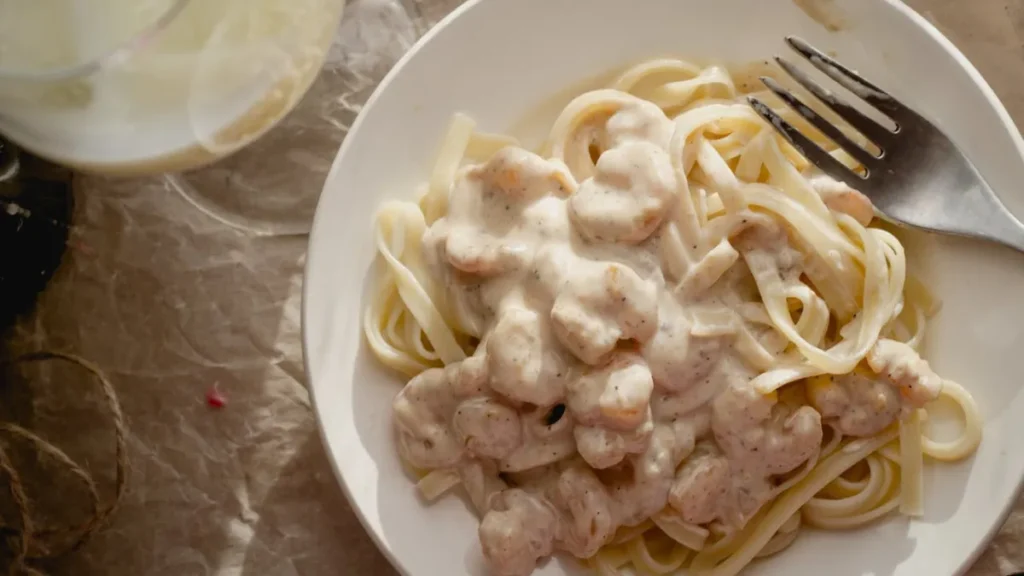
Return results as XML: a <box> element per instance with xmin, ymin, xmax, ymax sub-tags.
<box><xmin>394</xmin><ymin>99</ymin><xmax>941</xmax><ymax>576</ymax></box>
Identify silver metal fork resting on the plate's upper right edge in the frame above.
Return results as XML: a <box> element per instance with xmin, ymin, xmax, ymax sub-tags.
<box><xmin>748</xmin><ymin>36</ymin><xmax>1024</xmax><ymax>252</ymax></box>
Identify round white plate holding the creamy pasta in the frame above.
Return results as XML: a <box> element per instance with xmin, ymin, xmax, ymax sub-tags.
<box><xmin>303</xmin><ymin>0</ymin><xmax>1024</xmax><ymax>576</ymax></box>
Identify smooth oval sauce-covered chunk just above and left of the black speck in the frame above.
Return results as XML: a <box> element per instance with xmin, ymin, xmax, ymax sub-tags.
<box><xmin>486</xmin><ymin>306</ymin><xmax>569</xmax><ymax>406</ymax></box>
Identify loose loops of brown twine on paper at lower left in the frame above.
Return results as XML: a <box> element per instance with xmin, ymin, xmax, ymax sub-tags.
<box><xmin>0</xmin><ymin>352</ymin><xmax>128</xmax><ymax>576</ymax></box>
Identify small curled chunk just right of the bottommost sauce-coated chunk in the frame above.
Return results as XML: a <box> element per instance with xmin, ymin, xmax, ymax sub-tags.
<box><xmin>548</xmin><ymin>463</ymin><xmax>618</xmax><ymax>559</ymax></box>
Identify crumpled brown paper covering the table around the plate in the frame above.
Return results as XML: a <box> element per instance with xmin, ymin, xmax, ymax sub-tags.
<box><xmin>8</xmin><ymin>0</ymin><xmax>1024</xmax><ymax>576</ymax></box>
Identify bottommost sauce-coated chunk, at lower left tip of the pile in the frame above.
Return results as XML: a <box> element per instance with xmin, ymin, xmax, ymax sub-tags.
<box><xmin>478</xmin><ymin>488</ymin><xmax>558</xmax><ymax>576</ymax></box>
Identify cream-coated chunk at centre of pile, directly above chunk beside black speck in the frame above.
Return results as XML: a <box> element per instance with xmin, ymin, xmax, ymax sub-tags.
<box><xmin>551</xmin><ymin>263</ymin><xmax>657</xmax><ymax>365</ymax></box>
